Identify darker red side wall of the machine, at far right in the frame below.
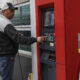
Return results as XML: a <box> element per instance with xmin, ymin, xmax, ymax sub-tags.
<box><xmin>65</xmin><ymin>0</ymin><xmax>80</xmax><ymax>80</ymax></box>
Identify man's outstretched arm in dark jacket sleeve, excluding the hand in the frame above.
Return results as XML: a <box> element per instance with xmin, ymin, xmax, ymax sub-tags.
<box><xmin>4</xmin><ymin>24</ymin><xmax>37</xmax><ymax>44</ymax></box>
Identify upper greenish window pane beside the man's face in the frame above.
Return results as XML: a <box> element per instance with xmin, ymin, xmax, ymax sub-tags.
<box><xmin>11</xmin><ymin>4</ymin><xmax>30</xmax><ymax>26</ymax></box>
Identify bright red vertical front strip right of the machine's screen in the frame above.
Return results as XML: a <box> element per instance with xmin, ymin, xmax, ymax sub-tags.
<box><xmin>54</xmin><ymin>0</ymin><xmax>67</xmax><ymax>80</ymax></box>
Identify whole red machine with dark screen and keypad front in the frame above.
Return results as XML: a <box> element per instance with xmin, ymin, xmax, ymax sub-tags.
<box><xmin>35</xmin><ymin>0</ymin><xmax>80</xmax><ymax>80</ymax></box>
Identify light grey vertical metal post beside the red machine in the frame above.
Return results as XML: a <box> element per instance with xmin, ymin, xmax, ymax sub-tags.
<box><xmin>30</xmin><ymin>0</ymin><xmax>38</xmax><ymax>80</ymax></box>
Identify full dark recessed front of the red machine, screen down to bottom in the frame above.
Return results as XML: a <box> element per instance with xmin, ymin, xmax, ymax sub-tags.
<box><xmin>40</xmin><ymin>8</ymin><xmax>56</xmax><ymax>80</ymax></box>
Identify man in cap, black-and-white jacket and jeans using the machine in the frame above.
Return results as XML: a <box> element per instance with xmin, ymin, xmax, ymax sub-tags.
<box><xmin>0</xmin><ymin>3</ymin><xmax>46</xmax><ymax>80</ymax></box>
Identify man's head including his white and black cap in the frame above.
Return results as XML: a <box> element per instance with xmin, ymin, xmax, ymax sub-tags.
<box><xmin>1</xmin><ymin>3</ymin><xmax>17</xmax><ymax>19</ymax></box>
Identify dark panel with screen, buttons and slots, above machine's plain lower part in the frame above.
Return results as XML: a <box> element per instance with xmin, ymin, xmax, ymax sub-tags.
<box><xmin>40</xmin><ymin>8</ymin><xmax>56</xmax><ymax>62</ymax></box>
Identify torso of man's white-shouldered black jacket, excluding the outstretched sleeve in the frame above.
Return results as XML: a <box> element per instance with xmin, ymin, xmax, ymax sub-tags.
<box><xmin>0</xmin><ymin>15</ymin><xmax>18</xmax><ymax>56</ymax></box>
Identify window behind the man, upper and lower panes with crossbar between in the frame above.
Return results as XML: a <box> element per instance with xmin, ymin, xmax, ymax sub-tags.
<box><xmin>11</xmin><ymin>3</ymin><xmax>31</xmax><ymax>52</ymax></box>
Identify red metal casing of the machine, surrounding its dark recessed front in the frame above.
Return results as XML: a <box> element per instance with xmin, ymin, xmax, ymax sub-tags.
<box><xmin>35</xmin><ymin>0</ymin><xmax>80</xmax><ymax>80</ymax></box>
